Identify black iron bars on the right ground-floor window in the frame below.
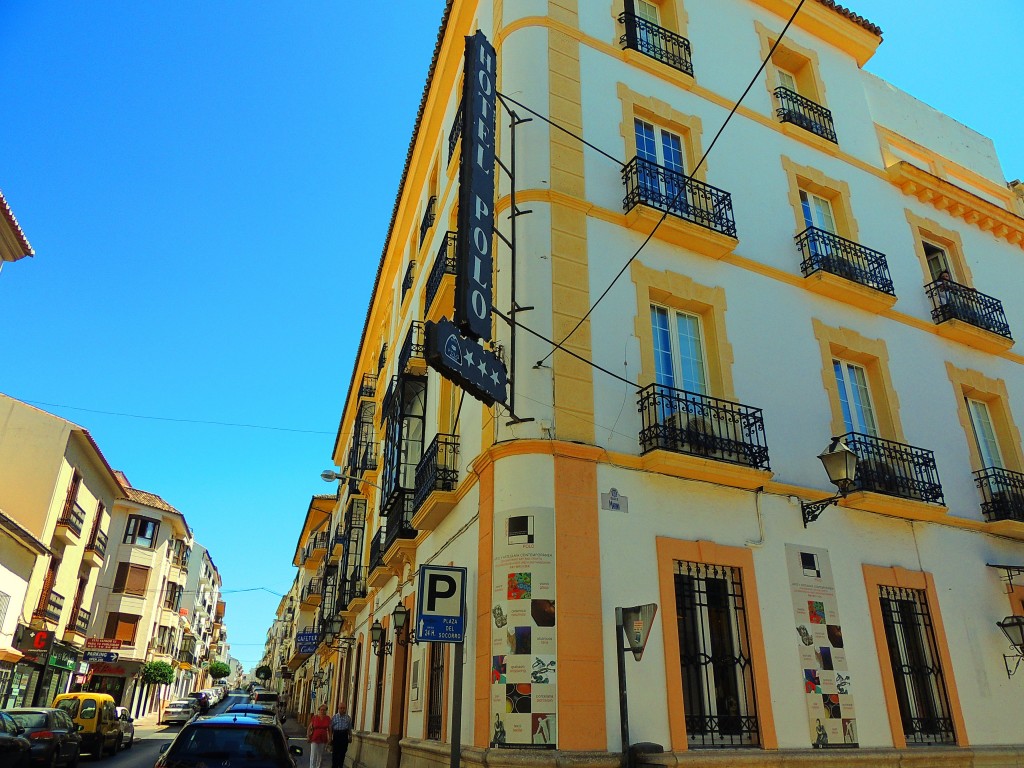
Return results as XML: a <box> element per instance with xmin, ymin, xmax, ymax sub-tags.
<box><xmin>879</xmin><ymin>586</ymin><xmax>956</xmax><ymax>744</ymax></box>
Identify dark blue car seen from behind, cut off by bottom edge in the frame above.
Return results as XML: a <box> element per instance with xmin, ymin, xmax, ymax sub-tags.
<box><xmin>155</xmin><ymin>714</ymin><xmax>302</xmax><ymax>768</ymax></box>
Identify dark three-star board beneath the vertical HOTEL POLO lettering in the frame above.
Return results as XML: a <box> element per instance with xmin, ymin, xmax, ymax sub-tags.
<box><xmin>424</xmin><ymin>318</ymin><xmax>508</xmax><ymax>406</ymax></box>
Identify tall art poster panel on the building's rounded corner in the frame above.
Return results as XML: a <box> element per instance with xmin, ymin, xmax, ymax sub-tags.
<box><xmin>490</xmin><ymin>507</ymin><xmax>558</xmax><ymax>750</ymax></box>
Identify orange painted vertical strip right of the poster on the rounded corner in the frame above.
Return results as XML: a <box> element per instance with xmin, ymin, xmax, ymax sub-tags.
<box><xmin>554</xmin><ymin>456</ymin><xmax>608</xmax><ymax>751</ymax></box>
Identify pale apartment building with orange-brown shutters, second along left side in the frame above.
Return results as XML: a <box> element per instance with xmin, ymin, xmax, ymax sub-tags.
<box><xmin>84</xmin><ymin>481</ymin><xmax>195</xmax><ymax>716</ymax></box>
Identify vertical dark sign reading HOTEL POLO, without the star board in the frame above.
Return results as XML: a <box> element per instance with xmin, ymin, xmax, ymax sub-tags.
<box><xmin>455</xmin><ymin>30</ymin><xmax>498</xmax><ymax>341</ymax></box>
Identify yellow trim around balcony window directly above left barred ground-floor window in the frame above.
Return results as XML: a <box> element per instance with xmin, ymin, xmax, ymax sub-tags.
<box><xmin>630</xmin><ymin>261</ymin><xmax>736</xmax><ymax>400</ymax></box>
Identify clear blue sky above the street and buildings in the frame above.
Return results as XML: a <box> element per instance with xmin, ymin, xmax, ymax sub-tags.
<box><xmin>0</xmin><ymin>0</ymin><xmax>1024</xmax><ymax>667</ymax></box>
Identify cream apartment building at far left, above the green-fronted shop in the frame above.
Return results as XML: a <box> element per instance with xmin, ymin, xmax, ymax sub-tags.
<box><xmin>0</xmin><ymin>395</ymin><xmax>125</xmax><ymax>707</ymax></box>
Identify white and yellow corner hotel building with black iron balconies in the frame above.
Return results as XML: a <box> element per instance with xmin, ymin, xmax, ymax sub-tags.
<box><xmin>319</xmin><ymin>0</ymin><xmax>1024</xmax><ymax>766</ymax></box>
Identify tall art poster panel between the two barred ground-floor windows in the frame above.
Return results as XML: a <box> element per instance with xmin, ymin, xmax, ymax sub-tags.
<box><xmin>785</xmin><ymin>544</ymin><xmax>858</xmax><ymax>750</ymax></box>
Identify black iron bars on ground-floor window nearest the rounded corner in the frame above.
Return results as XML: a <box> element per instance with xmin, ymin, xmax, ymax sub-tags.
<box><xmin>674</xmin><ymin>561</ymin><xmax>760</xmax><ymax>748</ymax></box>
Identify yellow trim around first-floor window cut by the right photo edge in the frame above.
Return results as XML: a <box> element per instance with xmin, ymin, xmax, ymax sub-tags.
<box><xmin>946</xmin><ymin>360</ymin><xmax>1024</xmax><ymax>472</ymax></box>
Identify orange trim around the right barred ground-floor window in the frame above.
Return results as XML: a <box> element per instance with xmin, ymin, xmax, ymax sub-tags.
<box><xmin>861</xmin><ymin>564</ymin><xmax>970</xmax><ymax>750</ymax></box>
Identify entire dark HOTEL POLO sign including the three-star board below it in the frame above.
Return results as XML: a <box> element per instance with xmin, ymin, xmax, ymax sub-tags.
<box><xmin>425</xmin><ymin>32</ymin><xmax>507</xmax><ymax>406</ymax></box>
